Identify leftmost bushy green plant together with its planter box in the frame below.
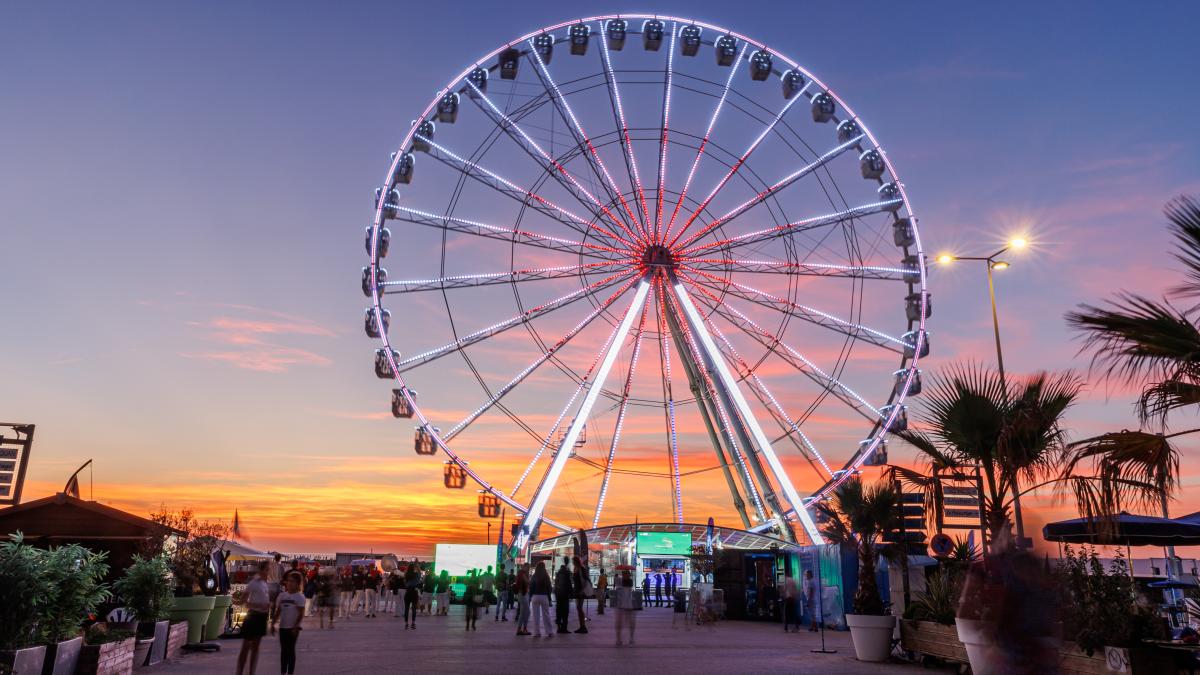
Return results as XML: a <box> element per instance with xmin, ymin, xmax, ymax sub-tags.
<box><xmin>0</xmin><ymin>532</ymin><xmax>52</xmax><ymax>675</ymax></box>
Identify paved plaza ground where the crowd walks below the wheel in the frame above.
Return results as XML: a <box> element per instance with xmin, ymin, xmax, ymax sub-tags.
<box><xmin>163</xmin><ymin>605</ymin><xmax>929</xmax><ymax>675</ymax></box>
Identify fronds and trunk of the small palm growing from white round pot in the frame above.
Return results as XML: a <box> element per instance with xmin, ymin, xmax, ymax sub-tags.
<box><xmin>817</xmin><ymin>477</ymin><xmax>900</xmax><ymax>615</ymax></box>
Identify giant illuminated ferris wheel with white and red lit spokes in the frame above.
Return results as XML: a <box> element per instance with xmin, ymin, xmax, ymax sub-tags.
<box><xmin>362</xmin><ymin>14</ymin><xmax>930</xmax><ymax>550</ymax></box>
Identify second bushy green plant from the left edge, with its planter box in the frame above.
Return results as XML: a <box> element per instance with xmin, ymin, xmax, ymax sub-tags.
<box><xmin>37</xmin><ymin>544</ymin><xmax>109</xmax><ymax>675</ymax></box>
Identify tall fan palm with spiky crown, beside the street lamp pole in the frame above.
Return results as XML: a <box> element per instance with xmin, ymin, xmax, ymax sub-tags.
<box><xmin>894</xmin><ymin>363</ymin><xmax>1082</xmax><ymax>540</ymax></box>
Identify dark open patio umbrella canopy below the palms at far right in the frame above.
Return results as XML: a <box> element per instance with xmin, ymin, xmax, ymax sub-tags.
<box><xmin>1042</xmin><ymin>513</ymin><xmax>1200</xmax><ymax>546</ymax></box>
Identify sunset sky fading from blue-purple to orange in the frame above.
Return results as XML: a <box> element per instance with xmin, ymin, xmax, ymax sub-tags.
<box><xmin>0</xmin><ymin>1</ymin><xmax>1200</xmax><ymax>555</ymax></box>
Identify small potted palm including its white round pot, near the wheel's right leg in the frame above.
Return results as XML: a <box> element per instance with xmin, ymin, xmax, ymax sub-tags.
<box><xmin>817</xmin><ymin>477</ymin><xmax>899</xmax><ymax>662</ymax></box>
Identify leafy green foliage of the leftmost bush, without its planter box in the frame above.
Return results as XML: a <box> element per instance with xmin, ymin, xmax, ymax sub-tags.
<box><xmin>0</xmin><ymin>532</ymin><xmax>53</xmax><ymax>650</ymax></box>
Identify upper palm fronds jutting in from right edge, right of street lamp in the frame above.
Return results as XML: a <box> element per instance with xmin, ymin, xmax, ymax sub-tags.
<box><xmin>1067</xmin><ymin>197</ymin><xmax>1200</xmax><ymax>425</ymax></box>
